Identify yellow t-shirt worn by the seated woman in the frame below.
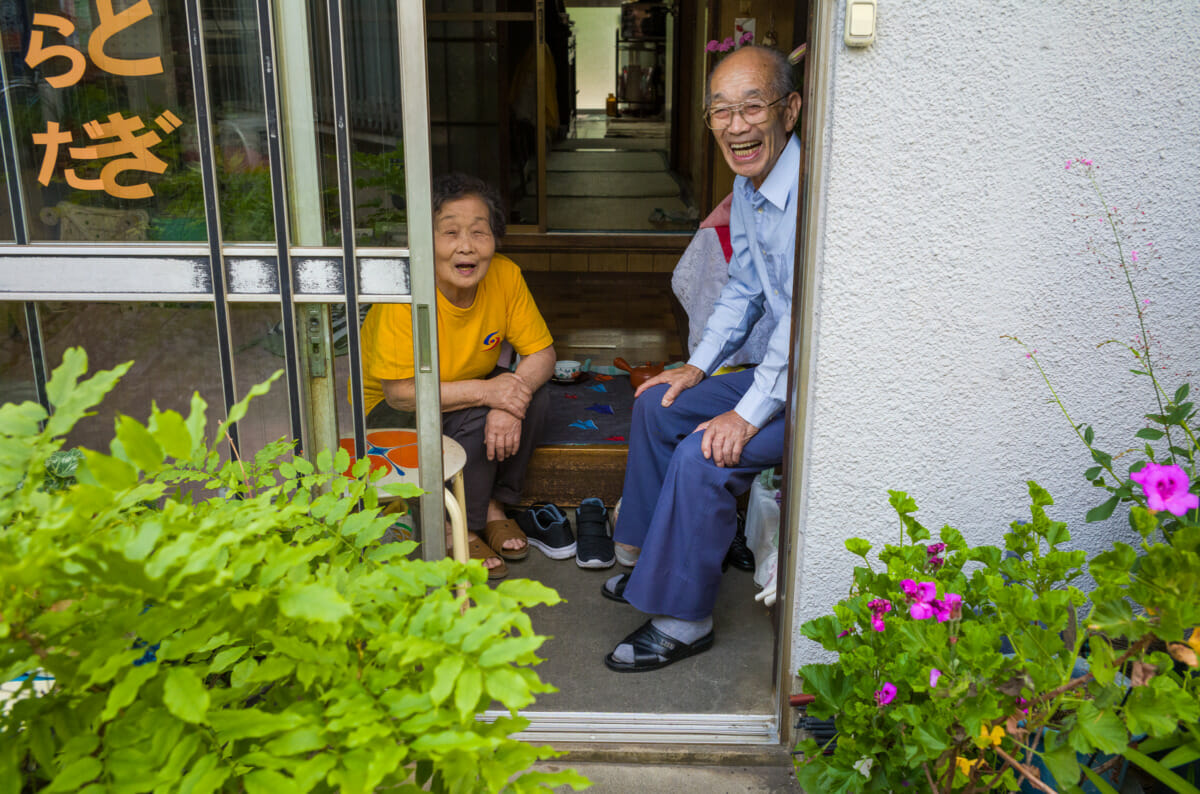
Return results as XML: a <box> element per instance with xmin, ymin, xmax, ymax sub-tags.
<box><xmin>362</xmin><ymin>254</ymin><xmax>554</xmax><ymax>414</ymax></box>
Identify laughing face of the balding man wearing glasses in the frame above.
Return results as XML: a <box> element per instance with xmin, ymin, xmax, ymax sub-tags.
<box><xmin>709</xmin><ymin>49</ymin><xmax>800</xmax><ymax>188</ymax></box>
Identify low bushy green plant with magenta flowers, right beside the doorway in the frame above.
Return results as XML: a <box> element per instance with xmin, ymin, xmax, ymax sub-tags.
<box><xmin>798</xmin><ymin>482</ymin><xmax>1099</xmax><ymax>792</ymax></box>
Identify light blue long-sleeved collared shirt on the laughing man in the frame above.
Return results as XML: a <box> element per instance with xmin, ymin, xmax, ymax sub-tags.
<box><xmin>688</xmin><ymin>136</ymin><xmax>800</xmax><ymax>427</ymax></box>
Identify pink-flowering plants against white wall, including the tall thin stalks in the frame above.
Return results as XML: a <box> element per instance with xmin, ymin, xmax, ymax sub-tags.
<box><xmin>798</xmin><ymin>158</ymin><xmax>1200</xmax><ymax>794</ymax></box>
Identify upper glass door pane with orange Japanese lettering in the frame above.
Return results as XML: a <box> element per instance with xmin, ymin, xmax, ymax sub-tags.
<box><xmin>2</xmin><ymin>0</ymin><xmax>204</xmax><ymax>241</ymax></box>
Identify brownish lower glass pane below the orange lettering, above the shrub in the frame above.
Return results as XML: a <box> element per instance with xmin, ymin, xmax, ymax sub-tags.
<box><xmin>40</xmin><ymin>302</ymin><xmax>224</xmax><ymax>451</ymax></box>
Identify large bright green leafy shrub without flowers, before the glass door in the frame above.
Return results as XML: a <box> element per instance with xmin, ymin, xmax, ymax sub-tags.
<box><xmin>0</xmin><ymin>349</ymin><xmax>586</xmax><ymax>793</ymax></box>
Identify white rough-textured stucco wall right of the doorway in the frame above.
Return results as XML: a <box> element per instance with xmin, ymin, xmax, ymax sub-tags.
<box><xmin>792</xmin><ymin>0</ymin><xmax>1200</xmax><ymax>667</ymax></box>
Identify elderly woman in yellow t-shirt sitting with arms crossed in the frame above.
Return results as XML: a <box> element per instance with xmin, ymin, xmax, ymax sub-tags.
<box><xmin>362</xmin><ymin>174</ymin><xmax>554</xmax><ymax>578</ymax></box>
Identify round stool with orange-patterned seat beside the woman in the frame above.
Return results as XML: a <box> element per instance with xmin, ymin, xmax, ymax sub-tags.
<box><xmin>337</xmin><ymin>427</ymin><xmax>467</xmax><ymax>563</ymax></box>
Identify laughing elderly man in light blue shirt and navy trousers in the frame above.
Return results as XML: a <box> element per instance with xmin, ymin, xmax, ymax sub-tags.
<box><xmin>602</xmin><ymin>47</ymin><xmax>800</xmax><ymax>673</ymax></box>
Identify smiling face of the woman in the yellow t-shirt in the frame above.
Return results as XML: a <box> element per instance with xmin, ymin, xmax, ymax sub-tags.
<box><xmin>433</xmin><ymin>196</ymin><xmax>496</xmax><ymax>308</ymax></box>
